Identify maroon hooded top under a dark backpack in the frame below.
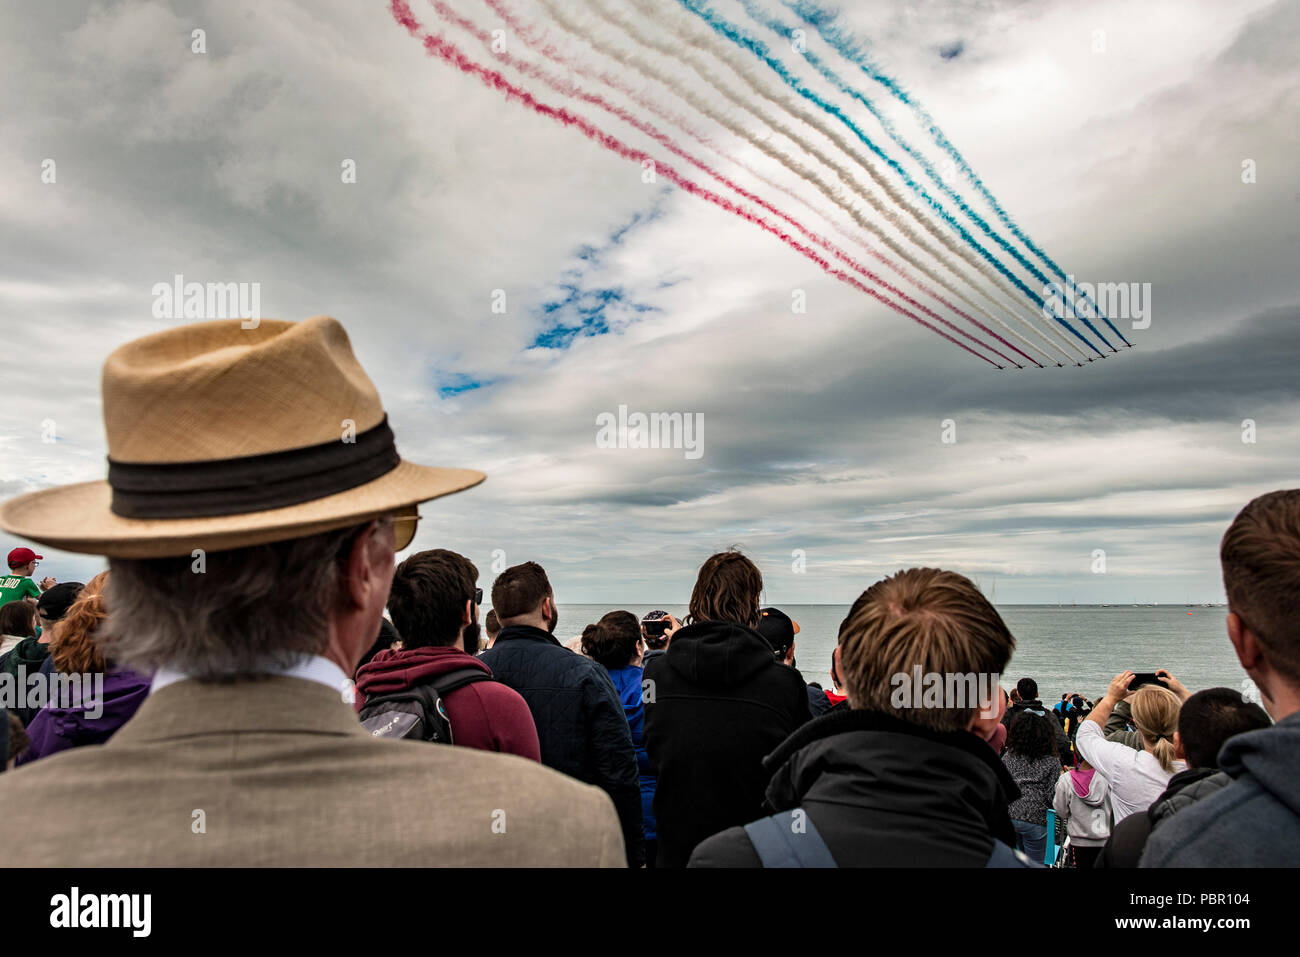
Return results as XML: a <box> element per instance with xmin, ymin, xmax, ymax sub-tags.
<box><xmin>356</xmin><ymin>648</ymin><xmax>542</xmax><ymax>762</ymax></box>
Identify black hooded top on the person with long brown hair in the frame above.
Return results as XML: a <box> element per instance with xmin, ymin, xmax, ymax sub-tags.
<box><xmin>645</xmin><ymin>622</ymin><xmax>811</xmax><ymax>867</ymax></box>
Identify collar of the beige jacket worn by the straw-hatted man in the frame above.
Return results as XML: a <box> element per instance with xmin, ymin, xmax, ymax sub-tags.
<box><xmin>104</xmin><ymin>676</ymin><xmax>371</xmax><ymax>748</ymax></box>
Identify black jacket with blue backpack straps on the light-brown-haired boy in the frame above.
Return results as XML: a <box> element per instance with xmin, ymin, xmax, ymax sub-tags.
<box><xmin>690</xmin><ymin>710</ymin><xmax>1021</xmax><ymax>867</ymax></box>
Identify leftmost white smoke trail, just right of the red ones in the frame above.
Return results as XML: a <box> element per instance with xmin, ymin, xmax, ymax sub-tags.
<box><xmin>538</xmin><ymin>0</ymin><xmax>1071</xmax><ymax>363</ymax></box>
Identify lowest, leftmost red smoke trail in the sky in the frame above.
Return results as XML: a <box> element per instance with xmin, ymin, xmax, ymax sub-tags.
<box><xmin>389</xmin><ymin>0</ymin><xmax>1002</xmax><ymax>369</ymax></box>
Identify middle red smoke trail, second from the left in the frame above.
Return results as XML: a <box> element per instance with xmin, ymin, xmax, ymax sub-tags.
<box><xmin>430</xmin><ymin>0</ymin><xmax>1041</xmax><ymax>368</ymax></box>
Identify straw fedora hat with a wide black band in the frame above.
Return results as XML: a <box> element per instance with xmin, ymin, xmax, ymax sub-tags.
<box><xmin>0</xmin><ymin>316</ymin><xmax>485</xmax><ymax>558</ymax></box>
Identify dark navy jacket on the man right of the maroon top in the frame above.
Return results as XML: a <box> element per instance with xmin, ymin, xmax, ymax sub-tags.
<box><xmin>478</xmin><ymin>625</ymin><xmax>645</xmax><ymax>867</ymax></box>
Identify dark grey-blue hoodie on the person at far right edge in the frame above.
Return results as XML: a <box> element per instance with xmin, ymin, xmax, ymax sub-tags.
<box><xmin>1139</xmin><ymin>713</ymin><xmax>1300</xmax><ymax>867</ymax></box>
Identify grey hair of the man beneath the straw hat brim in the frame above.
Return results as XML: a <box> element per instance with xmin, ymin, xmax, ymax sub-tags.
<box><xmin>103</xmin><ymin>524</ymin><xmax>365</xmax><ymax>681</ymax></box>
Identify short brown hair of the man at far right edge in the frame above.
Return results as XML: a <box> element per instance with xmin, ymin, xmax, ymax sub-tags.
<box><xmin>1219</xmin><ymin>489</ymin><xmax>1300</xmax><ymax>684</ymax></box>
